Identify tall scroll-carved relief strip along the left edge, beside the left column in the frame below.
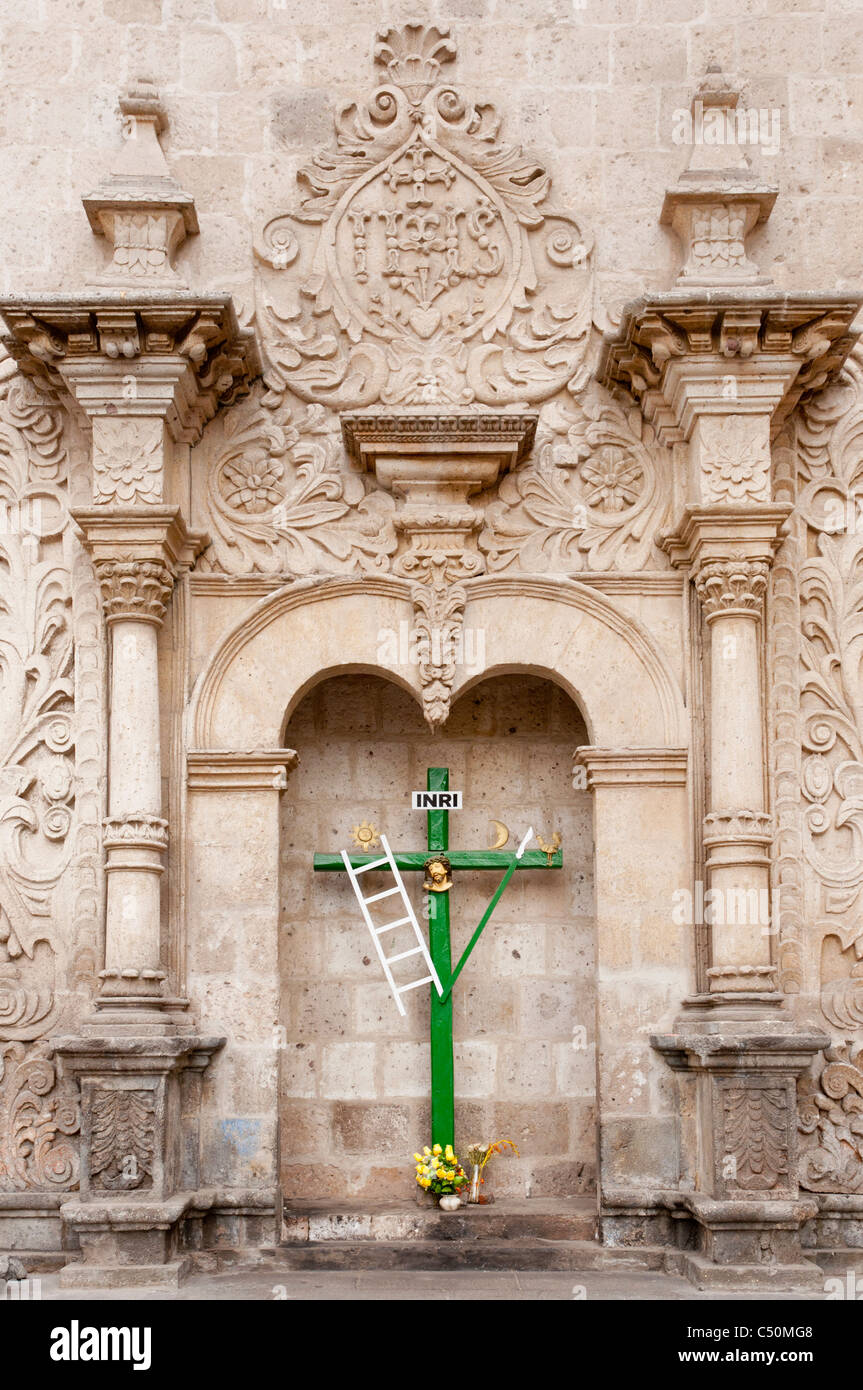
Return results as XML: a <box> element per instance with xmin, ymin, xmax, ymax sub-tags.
<box><xmin>0</xmin><ymin>341</ymin><xmax>97</xmax><ymax>1190</ymax></box>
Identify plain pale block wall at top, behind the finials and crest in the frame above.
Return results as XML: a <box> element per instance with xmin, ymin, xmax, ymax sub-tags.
<box><xmin>0</xmin><ymin>0</ymin><xmax>863</xmax><ymax>311</ymax></box>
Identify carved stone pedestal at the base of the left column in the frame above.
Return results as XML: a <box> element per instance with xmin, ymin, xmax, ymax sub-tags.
<box><xmin>57</xmin><ymin>1034</ymin><xmax>225</xmax><ymax>1289</ymax></box>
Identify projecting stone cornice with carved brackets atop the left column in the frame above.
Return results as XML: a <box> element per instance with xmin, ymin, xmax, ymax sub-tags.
<box><xmin>0</xmin><ymin>291</ymin><xmax>261</xmax><ymax>443</ymax></box>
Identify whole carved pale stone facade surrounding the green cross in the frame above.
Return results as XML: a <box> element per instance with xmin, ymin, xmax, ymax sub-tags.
<box><xmin>0</xmin><ymin>0</ymin><xmax>863</xmax><ymax>1286</ymax></box>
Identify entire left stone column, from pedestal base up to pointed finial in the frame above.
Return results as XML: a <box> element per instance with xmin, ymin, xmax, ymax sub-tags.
<box><xmin>0</xmin><ymin>82</ymin><xmax>260</xmax><ymax>1286</ymax></box>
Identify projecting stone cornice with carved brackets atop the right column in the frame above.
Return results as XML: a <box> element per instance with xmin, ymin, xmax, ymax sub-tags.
<box><xmin>598</xmin><ymin>288</ymin><xmax>863</xmax><ymax>443</ymax></box>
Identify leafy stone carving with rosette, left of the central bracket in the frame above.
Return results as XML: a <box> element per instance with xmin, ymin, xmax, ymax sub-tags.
<box><xmin>199</xmin><ymin>402</ymin><xmax>397</xmax><ymax>575</ymax></box>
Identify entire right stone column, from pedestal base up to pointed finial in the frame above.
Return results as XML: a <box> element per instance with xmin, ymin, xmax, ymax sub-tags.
<box><xmin>600</xmin><ymin>74</ymin><xmax>860</xmax><ymax>1289</ymax></box>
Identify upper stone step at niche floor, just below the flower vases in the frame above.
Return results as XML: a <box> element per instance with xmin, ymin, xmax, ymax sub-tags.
<box><xmin>282</xmin><ymin>1198</ymin><xmax>596</xmax><ymax>1247</ymax></box>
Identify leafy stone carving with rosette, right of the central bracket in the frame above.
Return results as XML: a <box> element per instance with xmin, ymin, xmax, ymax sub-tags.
<box><xmin>479</xmin><ymin>392</ymin><xmax>671</xmax><ymax>571</ymax></box>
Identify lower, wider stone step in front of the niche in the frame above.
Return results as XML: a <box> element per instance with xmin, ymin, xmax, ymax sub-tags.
<box><xmin>277</xmin><ymin>1237</ymin><xmax>667</xmax><ymax>1272</ymax></box>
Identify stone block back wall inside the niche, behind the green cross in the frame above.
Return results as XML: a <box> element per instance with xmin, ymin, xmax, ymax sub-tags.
<box><xmin>279</xmin><ymin>676</ymin><xmax>595</xmax><ymax>1198</ymax></box>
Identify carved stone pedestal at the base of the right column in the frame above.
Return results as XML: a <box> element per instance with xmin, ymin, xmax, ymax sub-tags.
<box><xmin>650</xmin><ymin>1016</ymin><xmax>828</xmax><ymax>1289</ymax></box>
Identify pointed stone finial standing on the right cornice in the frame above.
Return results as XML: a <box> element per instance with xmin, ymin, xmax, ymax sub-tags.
<box><xmin>660</xmin><ymin>65</ymin><xmax>778</xmax><ymax>288</ymax></box>
